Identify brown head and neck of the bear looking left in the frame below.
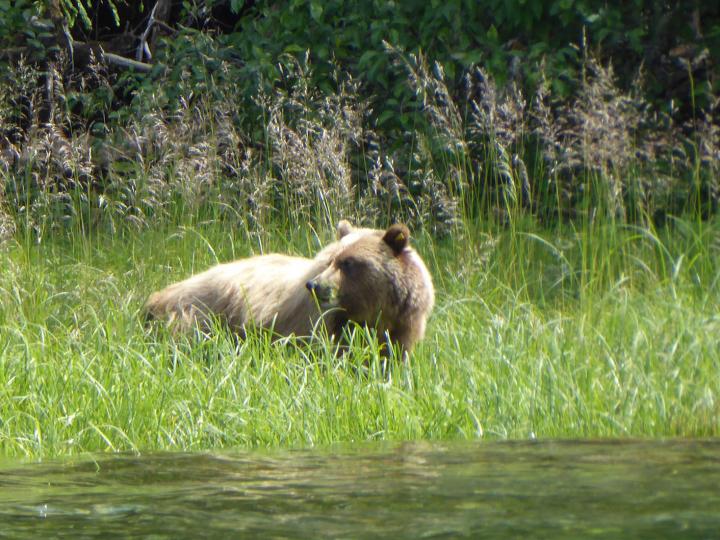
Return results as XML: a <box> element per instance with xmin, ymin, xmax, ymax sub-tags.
<box><xmin>306</xmin><ymin>222</ymin><xmax>434</xmax><ymax>350</ymax></box>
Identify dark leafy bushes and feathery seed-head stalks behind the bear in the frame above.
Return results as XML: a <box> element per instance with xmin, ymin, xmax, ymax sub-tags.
<box><xmin>0</xmin><ymin>0</ymin><xmax>720</xmax><ymax>240</ymax></box>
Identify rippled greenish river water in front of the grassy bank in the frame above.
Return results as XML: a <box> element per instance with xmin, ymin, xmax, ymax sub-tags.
<box><xmin>0</xmin><ymin>440</ymin><xmax>720</xmax><ymax>539</ymax></box>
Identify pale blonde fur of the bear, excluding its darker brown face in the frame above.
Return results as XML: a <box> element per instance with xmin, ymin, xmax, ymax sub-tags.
<box><xmin>145</xmin><ymin>221</ymin><xmax>434</xmax><ymax>350</ymax></box>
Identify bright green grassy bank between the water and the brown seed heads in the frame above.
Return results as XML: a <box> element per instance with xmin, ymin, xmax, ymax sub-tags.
<box><xmin>0</xmin><ymin>213</ymin><xmax>720</xmax><ymax>457</ymax></box>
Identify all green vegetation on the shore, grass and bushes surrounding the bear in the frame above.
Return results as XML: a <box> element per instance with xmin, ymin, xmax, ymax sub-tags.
<box><xmin>0</xmin><ymin>0</ymin><xmax>720</xmax><ymax>457</ymax></box>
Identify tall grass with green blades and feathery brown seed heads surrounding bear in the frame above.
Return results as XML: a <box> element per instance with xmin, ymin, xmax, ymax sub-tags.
<box><xmin>0</xmin><ymin>41</ymin><xmax>720</xmax><ymax>457</ymax></box>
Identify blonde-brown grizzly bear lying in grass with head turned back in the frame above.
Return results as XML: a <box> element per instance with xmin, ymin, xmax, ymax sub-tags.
<box><xmin>145</xmin><ymin>220</ymin><xmax>434</xmax><ymax>352</ymax></box>
